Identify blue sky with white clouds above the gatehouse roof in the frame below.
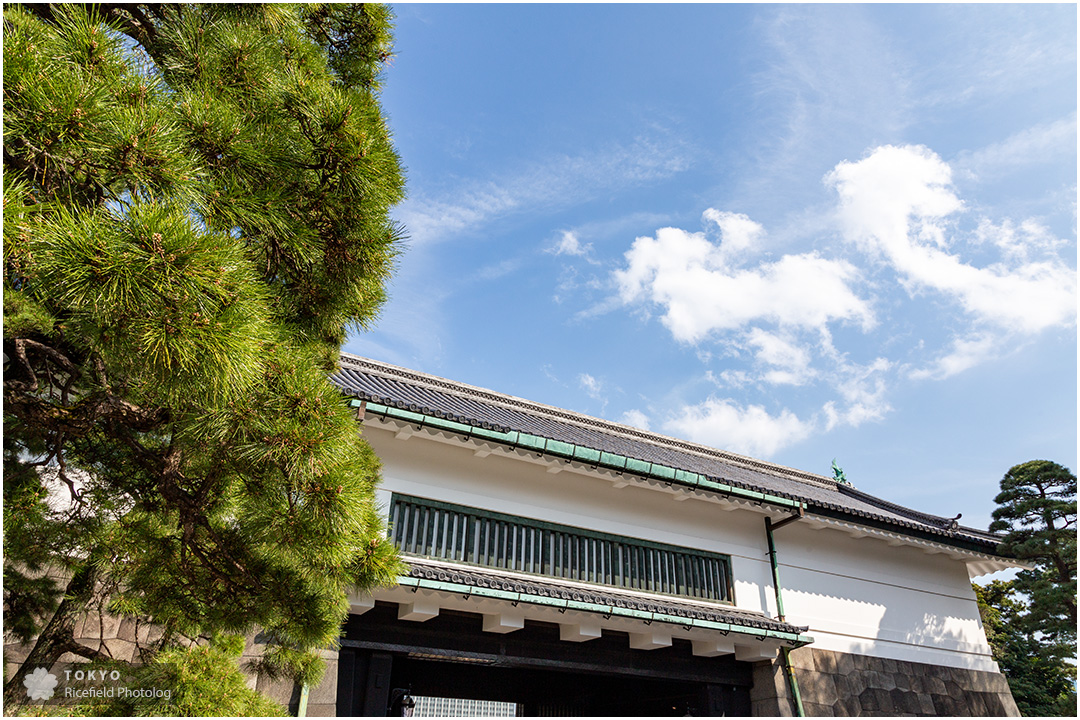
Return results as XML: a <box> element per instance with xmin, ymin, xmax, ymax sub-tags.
<box><xmin>345</xmin><ymin>4</ymin><xmax>1077</xmax><ymax>527</ymax></box>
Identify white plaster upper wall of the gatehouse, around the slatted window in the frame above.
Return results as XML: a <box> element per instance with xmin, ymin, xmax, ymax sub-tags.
<box><xmin>364</xmin><ymin>423</ymin><xmax>997</xmax><ymax>670</ymax></box>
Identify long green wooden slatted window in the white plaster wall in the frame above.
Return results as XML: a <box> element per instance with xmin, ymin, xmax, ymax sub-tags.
<box><xmin>390</xmin><ymin>493</ymin><xmax>732</xmax><ymax>602</ymax></box>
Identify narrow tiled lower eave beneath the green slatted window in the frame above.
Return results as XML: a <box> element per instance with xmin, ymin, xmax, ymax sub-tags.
<box><xmin>405</xmin><ymin>556</ymin><xmax>808</xmax><ymax>635</ymax></box>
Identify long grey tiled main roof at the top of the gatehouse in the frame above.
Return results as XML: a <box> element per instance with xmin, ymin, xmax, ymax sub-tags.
<box><xmin>332</xmin><ymin>354</ymin><xmax>999</xmax><ymax>555</ymax></box>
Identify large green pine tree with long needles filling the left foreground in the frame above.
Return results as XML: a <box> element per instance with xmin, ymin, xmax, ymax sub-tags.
<box><xmin>3</xmin><ymin>3</ymin><xmax>404</xmax><ymax>699</ymax></box>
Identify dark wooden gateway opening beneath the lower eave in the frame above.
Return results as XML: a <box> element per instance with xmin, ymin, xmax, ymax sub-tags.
<box><xmin>337</xmin><ymin>602</ymin><xmax>751</xmax><ymax>717</ymax></box>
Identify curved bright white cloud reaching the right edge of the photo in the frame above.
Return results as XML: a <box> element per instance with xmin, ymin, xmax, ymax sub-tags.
<box><xmin>825</xmin><ymin>146</ymin><xmax>1076</xmax><ymax>332</ymax></box>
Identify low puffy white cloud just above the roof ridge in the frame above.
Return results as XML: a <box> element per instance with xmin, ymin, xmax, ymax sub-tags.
<box><xmin>664</xmin><ymin>397</ymin><xmax>813</xmax><ymax>458</ymax></box>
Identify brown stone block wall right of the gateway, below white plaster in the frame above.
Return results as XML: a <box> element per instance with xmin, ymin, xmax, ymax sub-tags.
<box><xmin>751</xmin><ymin>647</ymin><xmax>1020</xmax><ymax>717</ymax></box>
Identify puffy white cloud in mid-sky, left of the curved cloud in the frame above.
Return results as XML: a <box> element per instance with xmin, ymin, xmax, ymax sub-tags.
<box><xmin>613</xmin><ymin>210</ymin><xmax>874</xmax><ymax>343</ymax></box>
